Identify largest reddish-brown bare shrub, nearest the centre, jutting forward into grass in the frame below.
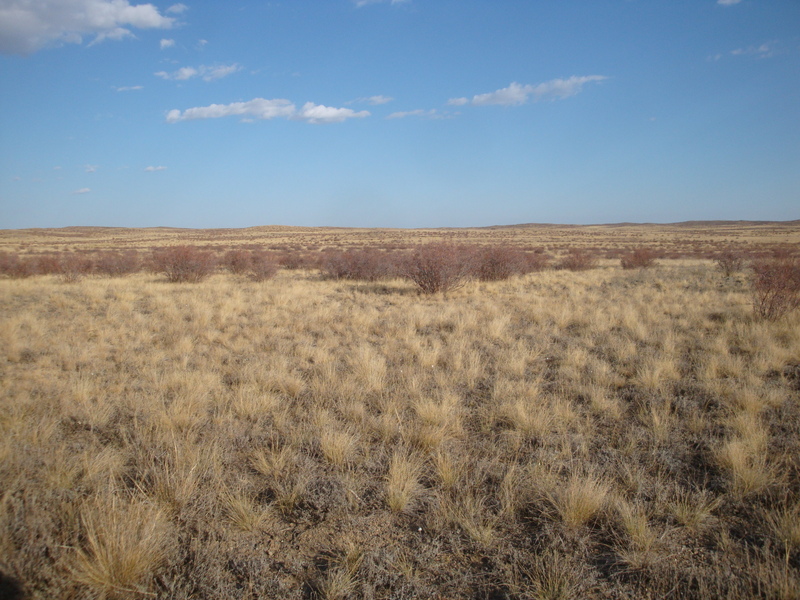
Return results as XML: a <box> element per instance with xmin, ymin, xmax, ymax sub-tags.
<box><xmin>400</xmin><ymin>243</ymin><xmax>474</xmax><ymax>294</ymax></box>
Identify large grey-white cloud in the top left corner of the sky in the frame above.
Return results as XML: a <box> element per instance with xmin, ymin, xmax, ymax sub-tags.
<box><xmin>0</xmin><ymin>0</ymin><xmax>175</xmax><ymax>54</ymax></box>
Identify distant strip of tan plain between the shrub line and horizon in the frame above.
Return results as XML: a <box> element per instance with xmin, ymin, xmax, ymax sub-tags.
<box><xmin>0</xmin><ymin>221</ymin><xmax>800</xmax><ymax>255</ymax></box>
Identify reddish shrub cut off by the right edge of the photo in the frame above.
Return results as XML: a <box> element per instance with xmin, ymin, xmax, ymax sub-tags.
<box><xmin>752</xmin><ymin>258</ymin><xmax>800</xmax><ymax>320</ymax></box>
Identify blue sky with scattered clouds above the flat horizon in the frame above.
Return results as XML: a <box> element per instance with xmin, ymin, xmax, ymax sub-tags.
<box><xmin>0</xmin><ymin>0</ymin><xmax>800</xmax><ymax>228</ymax></box>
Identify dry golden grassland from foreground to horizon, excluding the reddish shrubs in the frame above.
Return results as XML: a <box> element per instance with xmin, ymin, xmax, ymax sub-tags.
<box><xmin>0</xmin><ymin>222</ymin><xmax>800</xmax><ymax>600</ymax></box>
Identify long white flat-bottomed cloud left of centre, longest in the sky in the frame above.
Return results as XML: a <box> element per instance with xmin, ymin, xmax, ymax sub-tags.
<box><xmin>166</xmin><ymin>98</ymin><xmax>370</xmax><ymax>124</ymax></box>
